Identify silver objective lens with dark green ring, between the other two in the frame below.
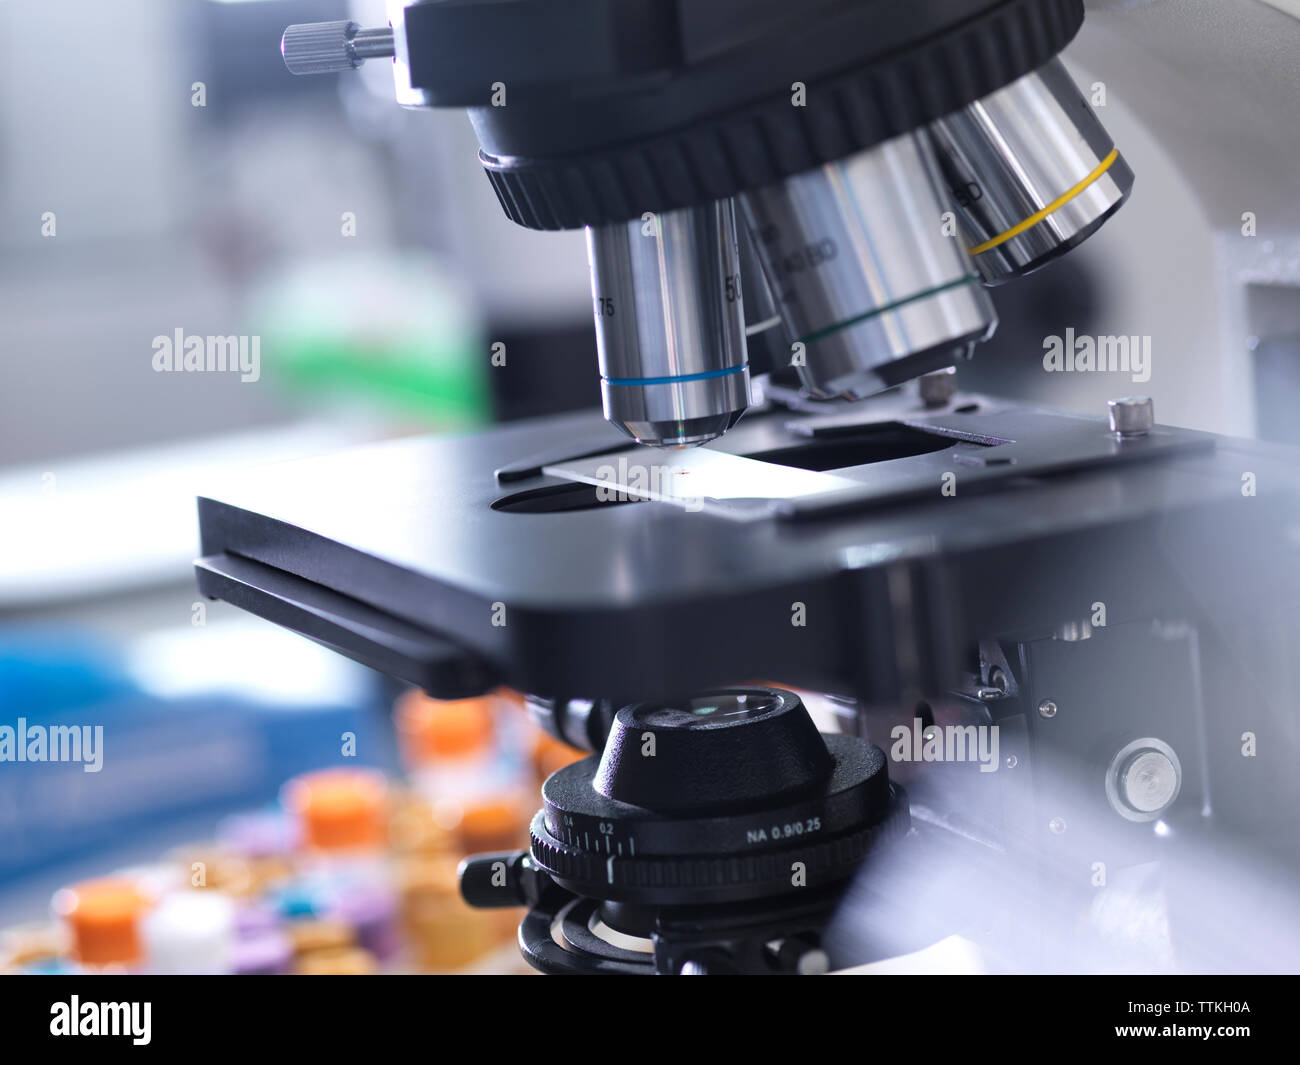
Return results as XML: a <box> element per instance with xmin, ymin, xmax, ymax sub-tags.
<box><xmin>738</xmin><ymin>134</ymin><xmax>997</xmax><ymax>399</ymax></box>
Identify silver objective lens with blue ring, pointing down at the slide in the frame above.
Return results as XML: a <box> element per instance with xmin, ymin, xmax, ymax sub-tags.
<box><xmin>586</xmin><ymin>200</ymin><xmax>749</xmax><ymax>447</ymax></box>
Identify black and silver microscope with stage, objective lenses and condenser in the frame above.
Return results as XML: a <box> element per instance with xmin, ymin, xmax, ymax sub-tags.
<box><xmin>196</xmin><ymin>0</ymin><xmax>1300</xmax><ymax>974</ymax></box>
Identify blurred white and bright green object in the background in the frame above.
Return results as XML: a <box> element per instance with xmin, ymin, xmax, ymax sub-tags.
<box><xmin>256</xmin><ymin>254</ymin><xmax>491</xmax><ymax>428</ymax></box>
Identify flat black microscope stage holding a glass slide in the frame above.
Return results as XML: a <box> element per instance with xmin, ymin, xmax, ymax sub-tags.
<box><xmin>198</xmin><ymin>395</ymin><xmax>1300</xmax><ymax>698</ymax></box>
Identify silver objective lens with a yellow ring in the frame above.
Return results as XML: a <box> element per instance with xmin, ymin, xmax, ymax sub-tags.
<box><xmin>930</xmin><ymin>60</ymin><xmax>1134</xmax><ymax>283</ymax></box>
